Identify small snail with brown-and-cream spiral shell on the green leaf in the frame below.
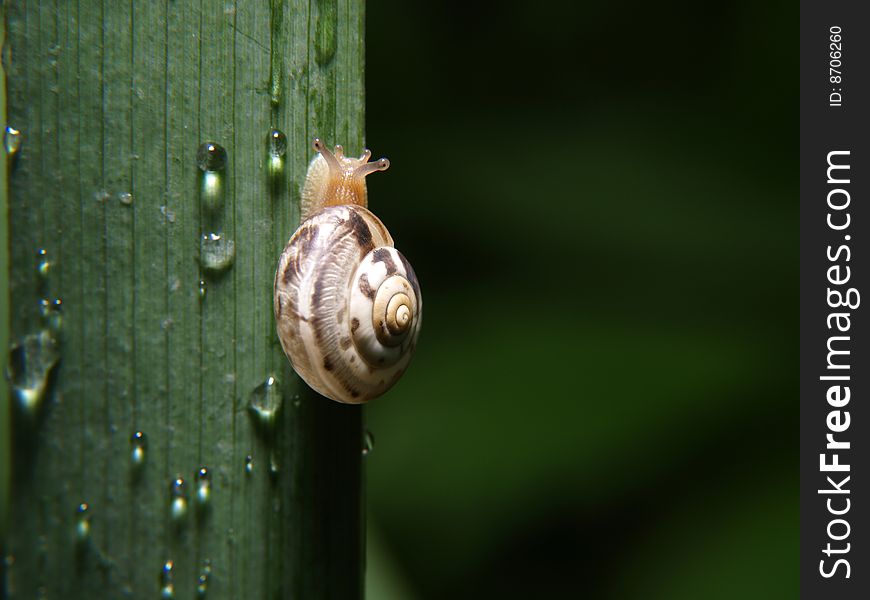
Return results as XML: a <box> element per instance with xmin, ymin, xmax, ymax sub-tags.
<box><xmin>275</xmin><ymin>138</ymin><xmax>422</xmax><ymax>404</ymax></box>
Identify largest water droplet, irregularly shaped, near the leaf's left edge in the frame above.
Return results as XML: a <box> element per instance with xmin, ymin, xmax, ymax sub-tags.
<box><xmin>7</xmin><ymin>331</ymin><xmax>60</xmax><ymax>416</ymax></box>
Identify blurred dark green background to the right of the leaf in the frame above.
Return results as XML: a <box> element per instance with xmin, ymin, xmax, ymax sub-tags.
<box><xmin>366</xmin><ymin>0</ymin><xmax>798</xmax><ymax>600</ymax></box>
